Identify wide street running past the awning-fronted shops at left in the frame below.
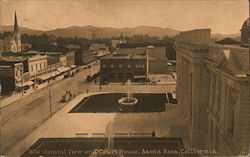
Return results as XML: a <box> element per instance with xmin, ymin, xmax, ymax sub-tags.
<box><xmin>0</xmin><ymin>65</ymin><xmax>99</xmax><ymax>153</ymax></box>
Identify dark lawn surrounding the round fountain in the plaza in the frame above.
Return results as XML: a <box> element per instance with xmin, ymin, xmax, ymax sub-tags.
<box><xmin>70</xmin><ymin>93</ymin><xmax>168</xmax><ymax>113</ymax></box>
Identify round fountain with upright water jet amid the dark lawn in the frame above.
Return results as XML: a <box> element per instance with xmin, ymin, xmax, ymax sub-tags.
<box><xmin>118</xmin><ymin>80</ymin><xmax>138</xmax><ymax>105</ymax></box>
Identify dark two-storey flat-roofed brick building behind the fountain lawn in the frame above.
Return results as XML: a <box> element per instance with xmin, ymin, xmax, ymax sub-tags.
<box><xmin>100</xmin><ymin>55</ymin><xmax>147</xmax><ymax>82</ymax></box>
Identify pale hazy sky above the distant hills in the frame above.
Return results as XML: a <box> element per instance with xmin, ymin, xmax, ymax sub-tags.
<box><xmin>0</xmin><ymin>0</ymin><xmax>249</xmax><ymax>34</ymax></box>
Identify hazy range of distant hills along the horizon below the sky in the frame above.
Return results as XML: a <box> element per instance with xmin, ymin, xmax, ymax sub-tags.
<box><xmin>0</xmin><ymin>26</ymin><xmax>179</xmax><ymax>38</ymax></box>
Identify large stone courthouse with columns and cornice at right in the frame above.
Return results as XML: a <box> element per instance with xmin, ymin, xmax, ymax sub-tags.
<box><xmin>175</xmin><ymin>19</ymin><xmax>250</xmax><ymax>155</ymax></box>
